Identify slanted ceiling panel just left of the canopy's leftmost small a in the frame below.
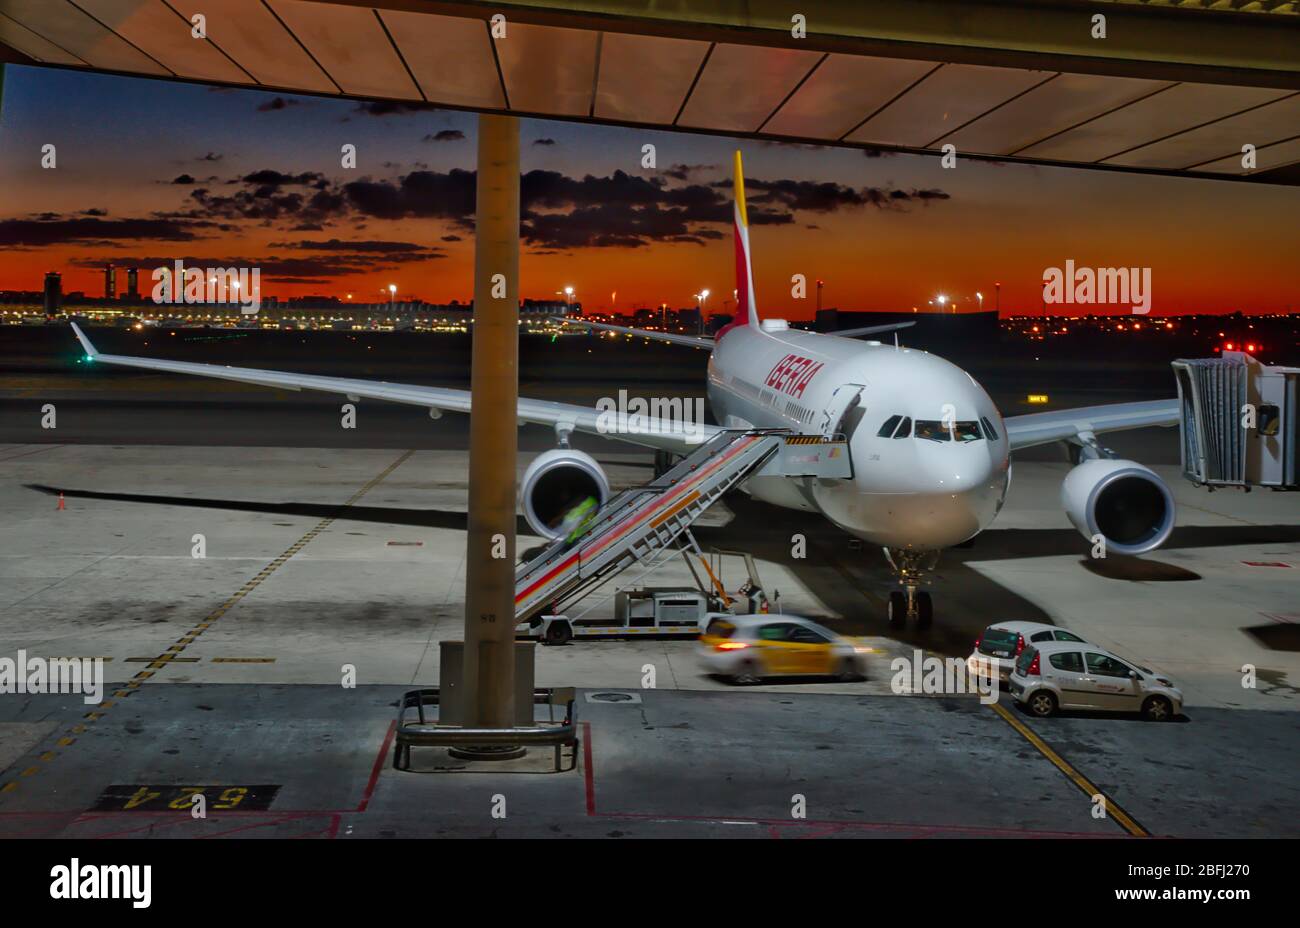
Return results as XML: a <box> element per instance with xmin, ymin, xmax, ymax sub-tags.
<box><xmin>77</xmin><ymin>0</ymin><xmax>252</xmax><ymax>83</ymax></box>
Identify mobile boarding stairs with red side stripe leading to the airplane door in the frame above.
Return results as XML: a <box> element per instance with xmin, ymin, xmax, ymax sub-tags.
<box><xmin>515</xmin><ymin>430</ymin><xmax>852</xmax><ymax>623</ymax></box>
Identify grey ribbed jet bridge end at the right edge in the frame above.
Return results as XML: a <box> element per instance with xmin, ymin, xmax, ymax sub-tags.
<box><xmin>1173</xmin><ymin>351</ymin><xmax>1300</xmax><ymax>490</ymax></box>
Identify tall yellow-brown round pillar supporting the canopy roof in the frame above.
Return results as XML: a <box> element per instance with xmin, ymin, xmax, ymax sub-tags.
<box><xmin>462</xmin><ymin>113</ymin><xmax>519</xmax><ymax>756</ymax></box>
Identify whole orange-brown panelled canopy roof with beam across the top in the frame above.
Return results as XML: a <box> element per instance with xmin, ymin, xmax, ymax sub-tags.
<box><xmin>0</xmin><ymin>0</ymin><xmax>1300</xmax><ymax>183</ymax></box>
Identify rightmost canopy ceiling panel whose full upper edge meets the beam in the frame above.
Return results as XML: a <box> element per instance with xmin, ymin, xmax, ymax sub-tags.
<box><xmin>1018</xmin><ymin>83</ymin><xmax>1291</xmax><ymax>161</ymax></box>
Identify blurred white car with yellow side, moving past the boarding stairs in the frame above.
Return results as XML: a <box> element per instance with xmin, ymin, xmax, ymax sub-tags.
<box><xmin>699</xmin><ymin>613</ymin><xmax>871</xmax><ymax>684</ymax></box>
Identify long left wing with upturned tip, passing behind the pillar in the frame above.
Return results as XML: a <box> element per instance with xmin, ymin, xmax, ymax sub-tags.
<box><xmin>73</xmin><ymin>322</ymin><xmax>722</xmax><ymax>454</ymax></box>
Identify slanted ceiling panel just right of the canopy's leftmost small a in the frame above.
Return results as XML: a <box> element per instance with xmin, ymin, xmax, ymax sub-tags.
<box><xmin>170</xmin><ymin>0</ymin><xmax>338</xmax><ymax>94</ymax></box>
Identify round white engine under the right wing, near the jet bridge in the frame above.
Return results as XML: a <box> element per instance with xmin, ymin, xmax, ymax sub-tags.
<box><xmin>1061</xmin><ymin>458</ymin><xmax>1174</xmax><ymax>554</ymax></box>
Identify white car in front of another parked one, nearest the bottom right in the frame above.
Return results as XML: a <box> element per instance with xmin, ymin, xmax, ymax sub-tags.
<box><xmin>1009</xmin><ymin>641</ymin><xmax>1183</xmax><ymax>721</ymax></box>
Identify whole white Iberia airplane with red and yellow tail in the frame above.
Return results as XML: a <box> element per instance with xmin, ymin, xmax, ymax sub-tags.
<box><xmin>73</xmin><ymin>151</ymin><xmax>1179</xmax><ymax>628</ymax></box>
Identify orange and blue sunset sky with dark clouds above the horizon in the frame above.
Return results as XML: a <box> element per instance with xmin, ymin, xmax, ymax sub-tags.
<box><xmin>0</xmin><ymin>65</ymin><xmax>1300</xmax><ymax>318</ymax></box>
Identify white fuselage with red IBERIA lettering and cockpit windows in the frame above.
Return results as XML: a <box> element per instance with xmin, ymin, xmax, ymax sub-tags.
<box><xmin>709</xmin><ymin>325</ymin><xmax>1011</xmax><ymax>550</ymax></box>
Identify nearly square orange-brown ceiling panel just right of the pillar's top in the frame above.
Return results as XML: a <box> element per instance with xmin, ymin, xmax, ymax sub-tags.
<box><xmin>497</xmin><ymin>22</ymin><xmax>601</xmax><ymax>116</ymax></box>
